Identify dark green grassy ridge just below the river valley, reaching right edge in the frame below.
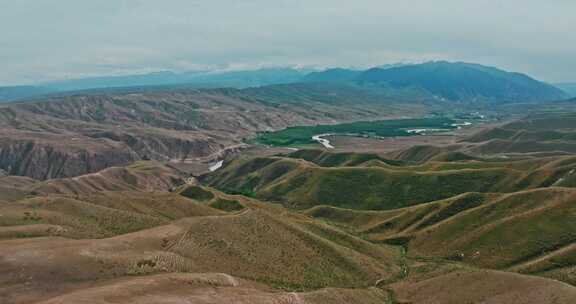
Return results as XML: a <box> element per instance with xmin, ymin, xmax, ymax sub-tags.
<box><xmin>203</xmin><ymin>150</ymin><xmax>576</xmax><ymax>210</ymax></box>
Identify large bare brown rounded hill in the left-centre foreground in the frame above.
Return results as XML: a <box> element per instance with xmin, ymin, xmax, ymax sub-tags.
<box><xmin>0</xmin><ymin>201</ymin><xmax>400</xmax><ymax>303</ymax></box>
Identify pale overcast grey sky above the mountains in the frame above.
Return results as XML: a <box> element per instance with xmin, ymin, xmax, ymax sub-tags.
<box><xmin>0</xmin><ymin>0</ymin><xmax>576</xmax><ymax>85</ymax></box>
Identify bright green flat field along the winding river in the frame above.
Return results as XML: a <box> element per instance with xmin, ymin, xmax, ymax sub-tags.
<box><xmin>256</xmin><ymin>118</ymin><xmax>456</xmax><ymax>146</ymax></box>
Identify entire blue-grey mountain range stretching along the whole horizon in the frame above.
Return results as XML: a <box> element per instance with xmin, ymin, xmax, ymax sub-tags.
<box><xmin>0</xmin><ymin>61</ymin><xmax>576</xmax><ymax>103</ymax></box>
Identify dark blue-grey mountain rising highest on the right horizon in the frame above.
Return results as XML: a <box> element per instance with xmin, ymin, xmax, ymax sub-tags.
<box><xmin>309</xmin><ymin>61</ymin><xmax>567</xmax><ymax>102</ymax></box>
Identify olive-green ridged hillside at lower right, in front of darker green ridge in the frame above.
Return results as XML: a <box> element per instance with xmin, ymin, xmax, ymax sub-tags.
<box><xmin>306</xmin><ymin>187</ymin><xmax>576</xmax><ymax>284</ymax></box>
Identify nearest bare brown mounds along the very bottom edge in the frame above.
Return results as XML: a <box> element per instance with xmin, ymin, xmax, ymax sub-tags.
<box><xmin>29</xmin><ymin>271</ymin><xmax>576</xmax><ymax>304</ymax></box>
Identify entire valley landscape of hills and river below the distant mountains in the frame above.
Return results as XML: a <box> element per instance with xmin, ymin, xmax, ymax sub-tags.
<box><xmin>0</xmin><ymin>62</ymin><xmax>576</xmax><ymax>304</ymax></box>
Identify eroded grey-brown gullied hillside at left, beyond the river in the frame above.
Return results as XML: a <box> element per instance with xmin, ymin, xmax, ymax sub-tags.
<box><xmin>0</xmin><ymin>85</ymin><xmax>429</xmax><ymax>179</ymax></box>
